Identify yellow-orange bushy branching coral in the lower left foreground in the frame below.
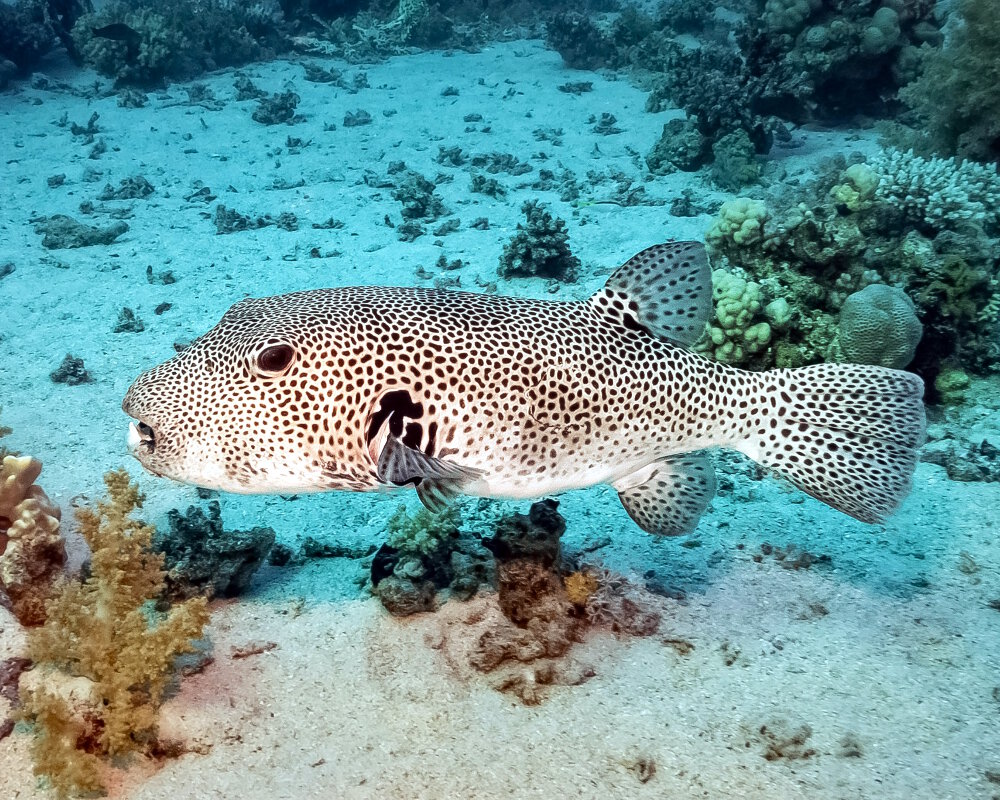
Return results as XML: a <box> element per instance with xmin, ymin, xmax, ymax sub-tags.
<box><xmin>21</xmin><ymin>471</ymin><xmax>208</xmax><ymax>795</ymax></box>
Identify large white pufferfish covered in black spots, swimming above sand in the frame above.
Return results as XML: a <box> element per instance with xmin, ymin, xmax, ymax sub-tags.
<box><xmin>122</xmin><ymin>242</ymin><xmax>925</xmax><ymax>535</ymax></box>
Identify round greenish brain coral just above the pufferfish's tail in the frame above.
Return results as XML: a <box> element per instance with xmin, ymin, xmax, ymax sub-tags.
<box><xmin>839</xmin><ymin>283</ymin><xmax>923</xmax><ymax>369</ymax></box>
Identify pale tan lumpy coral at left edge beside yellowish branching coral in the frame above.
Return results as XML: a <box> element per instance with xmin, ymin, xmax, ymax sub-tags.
<box><xmin>0</xmin><ymin>455</ymin><xmax>66</xmax><ymax>626</ymax></box>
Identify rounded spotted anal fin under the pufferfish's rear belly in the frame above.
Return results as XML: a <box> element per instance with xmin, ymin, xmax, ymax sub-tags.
<box><xmin>614</xmin><ymin>453</ymin><xmax>715</xmax><ymax>536</ymax></box>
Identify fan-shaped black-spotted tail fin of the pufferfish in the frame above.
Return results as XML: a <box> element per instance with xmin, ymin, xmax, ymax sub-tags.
<box><xmin>733</xmin><ymin>364</ymin><xmax>926</xmax><ymax>522</ymax></box>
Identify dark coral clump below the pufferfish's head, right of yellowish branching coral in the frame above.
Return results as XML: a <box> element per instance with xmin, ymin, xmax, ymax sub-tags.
<box><xmin>153</xmin><ymin>500</ymin><xmax>274</xmax><ymax>600</ymax></box>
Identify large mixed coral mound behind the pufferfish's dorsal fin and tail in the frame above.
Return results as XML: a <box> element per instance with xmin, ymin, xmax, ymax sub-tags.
<box><xmin>702</xmin><ymin>150</ymin><xmax>1000</xmax><ymax>384</ymax></box>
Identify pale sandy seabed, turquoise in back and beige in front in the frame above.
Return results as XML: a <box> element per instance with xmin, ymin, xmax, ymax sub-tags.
<box><xmin>0</xmin><ymin>42</ymin><xmax>1000</xmax><ymax>800</ymax></box>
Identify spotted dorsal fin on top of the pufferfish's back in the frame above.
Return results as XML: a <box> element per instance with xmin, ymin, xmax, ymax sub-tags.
<box><xmin>590</xmin><ymin>242</ymin><xmax>712</xmax><ymax>347</ymax></box>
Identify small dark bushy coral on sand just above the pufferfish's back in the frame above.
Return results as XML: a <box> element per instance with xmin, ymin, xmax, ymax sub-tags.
<box><xmin>498</xmin><ymin>200</ymin><xmax>580</xmax><ymax>282</ymax></box>
